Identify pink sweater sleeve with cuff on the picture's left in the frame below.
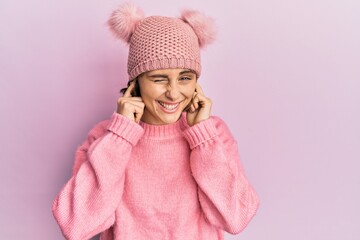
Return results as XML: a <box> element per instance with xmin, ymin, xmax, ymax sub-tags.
<box><xmin>52</xmin><ymin>113</ymin><xmax>143</xmax><ymax>240</ymax></box>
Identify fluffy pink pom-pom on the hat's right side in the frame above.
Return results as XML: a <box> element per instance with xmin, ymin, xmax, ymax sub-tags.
<box><xmin>180</xmin><ymin>10</ymin><xmax>216</xmax><ymax>48</ymax></box>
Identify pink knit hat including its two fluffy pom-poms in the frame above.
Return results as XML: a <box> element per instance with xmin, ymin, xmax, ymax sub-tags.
<box><xmin>108</xmin><ymin>4</ymin><xmax>215</xmax><ymax>80</ymax></box>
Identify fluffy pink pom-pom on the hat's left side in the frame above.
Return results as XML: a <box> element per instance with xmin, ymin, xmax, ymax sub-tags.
<box><xmin>107</xmin><ymin>3</ymin><xmax>144</xmax><ymax>43</ymax></box>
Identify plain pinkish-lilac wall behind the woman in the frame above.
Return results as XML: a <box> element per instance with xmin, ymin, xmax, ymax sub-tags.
<box><xmin>0</xmin><ymin>0</ymin><xmax>360</xmax><ymax>240</ymax></box>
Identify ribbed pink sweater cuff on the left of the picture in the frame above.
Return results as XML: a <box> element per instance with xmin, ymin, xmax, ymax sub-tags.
<box><xmin>107</xmin><ymin>112</ymin><xmax>144</xmax><ymax>146</ymax></box>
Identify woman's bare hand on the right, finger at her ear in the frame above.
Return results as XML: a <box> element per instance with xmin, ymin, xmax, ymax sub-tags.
<box><xmin>186</xmin><ymin>83</ymin><xmax>212</xmax><ymax>126</ymax></box>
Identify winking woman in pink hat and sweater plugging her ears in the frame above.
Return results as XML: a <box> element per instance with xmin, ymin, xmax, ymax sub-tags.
<box><xmin>53</xmin><ymin>5</ymin><xmax>258</xmax><ymax>240</ymax></box>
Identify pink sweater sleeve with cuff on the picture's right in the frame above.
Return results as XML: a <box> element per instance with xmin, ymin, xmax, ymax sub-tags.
<box><xmin>184</xmin><ymin>117</ymin><xmax>259</xmax><ymax>234</ymax></box>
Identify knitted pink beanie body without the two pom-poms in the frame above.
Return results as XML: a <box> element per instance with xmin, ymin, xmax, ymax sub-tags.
<box><xmin>128</xmin><ymin>16</ymin><xmax>201</xmax><ymax>79</ymax></box>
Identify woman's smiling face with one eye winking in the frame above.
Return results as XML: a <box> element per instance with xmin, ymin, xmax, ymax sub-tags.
<box><xmin>138</xmin><ymin>68</ymin><xmax>197</xmax><ymax>125</ymax></box>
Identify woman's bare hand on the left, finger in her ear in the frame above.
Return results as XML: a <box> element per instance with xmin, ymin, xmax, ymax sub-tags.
<box><xmin>117</xmin><ymin>81</ymin><xmax>145</xmax><ymax>123</ymax></box>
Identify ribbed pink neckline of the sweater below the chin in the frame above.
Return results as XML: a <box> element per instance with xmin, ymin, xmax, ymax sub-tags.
<box><xmin>139</xmin><ymin>113</ymin><xmax>190</xmax><ymax>138</ymax></box>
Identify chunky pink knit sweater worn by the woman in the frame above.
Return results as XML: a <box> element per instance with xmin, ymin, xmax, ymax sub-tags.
<box><xmin>52</xmin><ymin>113</ymin><xmax>259</xmax><ymax>240</ymax></box>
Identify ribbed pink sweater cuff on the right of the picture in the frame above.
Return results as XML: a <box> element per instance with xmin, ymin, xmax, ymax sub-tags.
<box><xmin>183</xmin><ymin>117</ymin><xmax>218</xmax><ymax>149</ymax></box>
